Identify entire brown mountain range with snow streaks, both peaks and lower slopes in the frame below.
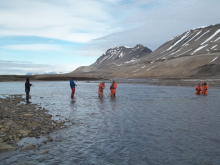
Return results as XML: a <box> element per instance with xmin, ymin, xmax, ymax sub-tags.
<box><xmin>71</xmin><ymin>24</ymin><xmax>220</xmax><ymax>78</ymax></box>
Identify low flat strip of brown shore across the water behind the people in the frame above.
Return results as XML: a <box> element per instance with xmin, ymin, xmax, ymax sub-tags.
<box><xmin>0</xmin><ymin>75</ymin><xmax>220</xmax><ymax>87</ymax></box>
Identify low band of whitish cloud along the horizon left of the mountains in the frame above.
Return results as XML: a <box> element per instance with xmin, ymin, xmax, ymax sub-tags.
<box><xmin>0</xmin><ymin>60</ymin><xmax>80</xmax><ymax>75</ymax></box>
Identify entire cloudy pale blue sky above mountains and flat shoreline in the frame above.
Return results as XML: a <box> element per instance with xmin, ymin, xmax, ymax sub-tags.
<box><xmin>0</xmin><ymin>0</ymin><xmax>220</xmax><ymax>75</ymax></box>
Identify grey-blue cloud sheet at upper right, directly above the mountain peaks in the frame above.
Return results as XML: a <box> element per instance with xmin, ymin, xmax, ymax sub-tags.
<box><xmin>80</xmin><ymin>0</ymin><xmax>220</xmax><ymax>55</ymax></box>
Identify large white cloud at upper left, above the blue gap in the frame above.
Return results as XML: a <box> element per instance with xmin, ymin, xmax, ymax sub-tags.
<box><xmin>0</xmin><ymin>0</ymin><xmax>116</xmax><ymax>42</ymax></box>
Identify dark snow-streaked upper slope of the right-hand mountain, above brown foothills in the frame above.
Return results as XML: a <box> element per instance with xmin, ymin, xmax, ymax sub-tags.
<box><xmin>141</xmin><ymin>24</ymin><xmax>220</xmax><ymax>61</ymax></box>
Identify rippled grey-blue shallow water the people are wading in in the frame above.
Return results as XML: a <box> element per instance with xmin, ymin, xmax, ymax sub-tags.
<box><xmin>0</xmin><ymin>81</ymin><xmax>220</xmax><ymax>165</ymax></box>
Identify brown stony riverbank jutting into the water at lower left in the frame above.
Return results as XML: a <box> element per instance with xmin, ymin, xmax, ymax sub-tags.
<box><xmin>0</xmin><ymin>95</ymin><xmax>66</xmax><ymax>152</ymax></box>
